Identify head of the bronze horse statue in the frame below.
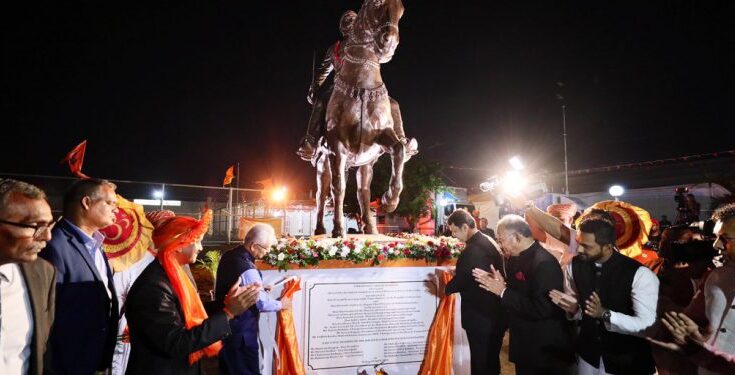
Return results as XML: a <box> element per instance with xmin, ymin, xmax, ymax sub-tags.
<box><xmin>352</xmin><ymin>0</ymin><xmax>404</xmax><ymax>64</ymax></box>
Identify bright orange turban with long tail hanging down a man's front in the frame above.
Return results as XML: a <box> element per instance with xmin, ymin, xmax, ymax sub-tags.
<box><xmin>149</xmin><ymin>210</ymin><xmax>222</xmax><ymax>364</ymax></box>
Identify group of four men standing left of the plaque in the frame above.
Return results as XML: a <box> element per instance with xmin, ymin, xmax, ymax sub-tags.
<box><xmin>0</xmin><ymin>179</ymin><xmax>290</xmax><ymax>375</ymax></box>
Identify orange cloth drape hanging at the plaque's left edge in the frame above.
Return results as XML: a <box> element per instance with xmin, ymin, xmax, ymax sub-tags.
<box><xmin>274</xmin><ymin>278</ymin><xmax>306</xmax><ymax>375</ymax></box>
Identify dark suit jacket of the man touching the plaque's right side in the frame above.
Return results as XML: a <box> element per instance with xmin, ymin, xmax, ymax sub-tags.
<box><xmin>445</xmin><ymin>231</ymin><xmax>506</xmax><ymax>333</ymax></box>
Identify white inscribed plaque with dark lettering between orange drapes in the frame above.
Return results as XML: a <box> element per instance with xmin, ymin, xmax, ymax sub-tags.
<box><xmin>304</xmin><ymin>281</ymin><xmax>438</xmax><ymax>370</ymax></box>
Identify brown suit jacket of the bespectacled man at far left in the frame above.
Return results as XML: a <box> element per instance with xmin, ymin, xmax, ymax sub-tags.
<box><xmin>19</xmin><ymin>259</ymin><xmax>56</xmax><ymax>375</ymax></box>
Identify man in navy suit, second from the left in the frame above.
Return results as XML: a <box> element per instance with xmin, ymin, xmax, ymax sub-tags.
<box><xmin>41</xmin><ymin>179</ymin><xmax>119</xmax><ymax>375</ymax></box>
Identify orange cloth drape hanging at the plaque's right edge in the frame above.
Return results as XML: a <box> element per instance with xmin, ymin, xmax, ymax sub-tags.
<box><xmin>419</xmin><ymin>272</ymin><xmax>455</xmax><ymax>375</ymax></box>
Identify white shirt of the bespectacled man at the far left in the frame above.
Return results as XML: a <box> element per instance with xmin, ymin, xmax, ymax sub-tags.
<box><xmin>0</xmin><ymin>263</ymin><xmax>33</xmax><ymax>374</ymax></box>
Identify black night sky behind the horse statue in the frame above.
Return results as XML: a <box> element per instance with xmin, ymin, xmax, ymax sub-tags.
<box><xmin>0</xmin><ymin>0</ymin><xmax>735</xmax><ymax>191</ymax></box>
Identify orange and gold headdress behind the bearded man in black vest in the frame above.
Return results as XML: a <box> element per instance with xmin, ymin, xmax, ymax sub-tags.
<box><xmin>576</xmin><ymin>201</ymin><xmax>651</xmax><ymax>258</ymax></box>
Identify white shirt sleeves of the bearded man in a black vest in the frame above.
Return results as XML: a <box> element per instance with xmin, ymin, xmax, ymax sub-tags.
<box><xmin>564</xmin><ymin>263</ymin><xmax>659</xmax><ymax>337</ymax></box>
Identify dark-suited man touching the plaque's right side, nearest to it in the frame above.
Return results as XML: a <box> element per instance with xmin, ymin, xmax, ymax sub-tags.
<box><xmin>445</xmin><ymin>210</ymin><xmax>507</xmax><ymax>375</ymax></box>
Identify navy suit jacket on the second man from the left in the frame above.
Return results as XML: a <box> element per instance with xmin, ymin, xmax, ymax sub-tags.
<box><xmin>40</xmin><ymin>220</ymin><xmax>119</xmax><ymax>375</ymax></box>
